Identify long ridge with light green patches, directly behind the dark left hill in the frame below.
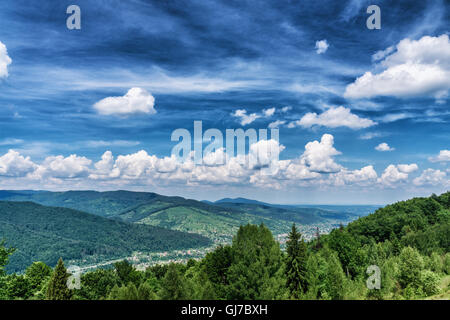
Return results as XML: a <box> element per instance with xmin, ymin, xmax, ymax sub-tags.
<box><xmin>0</xmin><ymin>191</ymin><xmax>314</xmax><ymax>241</ymax></box>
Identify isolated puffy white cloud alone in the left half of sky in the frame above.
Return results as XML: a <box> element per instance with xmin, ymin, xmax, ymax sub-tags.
<box><xmin>94</xmin><ymin>88</ymin><xmax>156</xmax><ymax>115</ymax></box>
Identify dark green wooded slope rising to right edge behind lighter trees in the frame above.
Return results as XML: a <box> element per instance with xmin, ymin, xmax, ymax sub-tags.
<box><xmin>316</xmin><ymin>192</ymin><xmax>450</xmax><ymax>276</ymax></box>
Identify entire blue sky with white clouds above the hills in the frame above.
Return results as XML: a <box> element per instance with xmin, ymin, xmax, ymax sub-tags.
<box><xmin>0</xmin><ymin>0</ymin><xmax>450</xmax><ymax>203</ymax></box>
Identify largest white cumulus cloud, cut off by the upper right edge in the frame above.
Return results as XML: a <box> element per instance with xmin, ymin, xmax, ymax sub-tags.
<box><xmin>344</xmin><ymin>34</ymin><xmax>450</xmax><ymax>99</ymax></box>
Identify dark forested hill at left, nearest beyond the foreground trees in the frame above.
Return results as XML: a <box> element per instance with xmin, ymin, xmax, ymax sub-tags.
<box><xmin>0</xmin><ymin>201</ymin><xmax>211</xmax><ymax>271</ymax></box>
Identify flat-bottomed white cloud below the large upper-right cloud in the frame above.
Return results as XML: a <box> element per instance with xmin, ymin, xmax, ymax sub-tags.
<box><xmin>291</xmin><ymin>106</ymin><xmax>376</xmax><ymax>129</ymax></box>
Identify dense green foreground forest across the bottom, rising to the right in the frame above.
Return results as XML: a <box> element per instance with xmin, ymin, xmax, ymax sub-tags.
<box><xmin>0</xmin><ymin>192</ymin><xmax>450</xmax><ymax>300</ymax></box>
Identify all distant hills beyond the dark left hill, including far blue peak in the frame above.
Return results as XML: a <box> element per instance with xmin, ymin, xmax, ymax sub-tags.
<box><xmin>0</xmin><ymin>190</ymin><xmax>369</xmax><ymax>242</ymax></box>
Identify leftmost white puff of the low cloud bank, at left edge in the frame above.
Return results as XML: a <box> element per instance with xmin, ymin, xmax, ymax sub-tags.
<box><xmin>0</xmin><ymin>150</ymin><xmax>37</xmax><ymax>177</ymax></box>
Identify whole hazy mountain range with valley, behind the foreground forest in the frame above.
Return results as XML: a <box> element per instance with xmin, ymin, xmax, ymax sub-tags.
<box><xmin>0</xmin><ymin>190</ymin><xmax>378</xmax><ymax>271</ymax></box>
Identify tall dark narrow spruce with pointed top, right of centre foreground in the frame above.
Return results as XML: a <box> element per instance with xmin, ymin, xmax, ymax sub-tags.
<box><xmin>286</xmin><ymin>223</ymin><xmax>307</xmax><ymax>299</ymax></box>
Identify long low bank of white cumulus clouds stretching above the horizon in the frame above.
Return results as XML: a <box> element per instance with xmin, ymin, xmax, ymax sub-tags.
<box><xmin>0</xmin><ymin>134</ymin><xmax>436</xmax><ymax>189</ymax></box>
